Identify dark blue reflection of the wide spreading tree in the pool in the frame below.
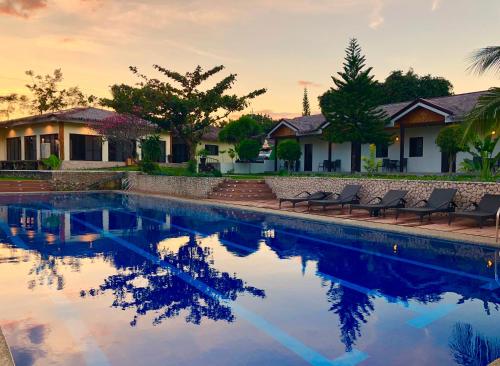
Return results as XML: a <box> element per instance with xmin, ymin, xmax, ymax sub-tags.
<box><xmin>81</xmin><ymin>235</ymin><xmax>265</xmax><ymax>326</ymax></box>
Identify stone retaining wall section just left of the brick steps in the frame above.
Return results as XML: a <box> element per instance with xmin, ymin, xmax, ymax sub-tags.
<box><xmin>128</xmin><ymin>173</ymin><xmax>224</xmax><ymax>198</ymax></box>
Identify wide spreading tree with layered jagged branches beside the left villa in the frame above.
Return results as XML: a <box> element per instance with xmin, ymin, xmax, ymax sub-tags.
<box><xmin>102</xmin><ymin>65</ymin><xmax>266</xmax><ymax>159</ymax></box>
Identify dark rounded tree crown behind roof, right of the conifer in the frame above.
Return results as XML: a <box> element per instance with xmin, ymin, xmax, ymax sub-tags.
<box><xmin>379</xmin><ymin>69</ymin><xmax>453</xmax><ymax>104</ymax></box>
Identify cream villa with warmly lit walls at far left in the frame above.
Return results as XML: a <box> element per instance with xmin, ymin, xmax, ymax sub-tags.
<box><xmin>0</xmin><ymin>107</ymin><xmax>172</xmax><ymax>169</ymax></box>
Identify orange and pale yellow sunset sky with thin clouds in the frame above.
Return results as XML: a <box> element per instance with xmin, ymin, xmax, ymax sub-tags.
<box><xmin>0</xmin><ymin>0</ymin><xmax>500</xmax><ymax>117</ymax></box>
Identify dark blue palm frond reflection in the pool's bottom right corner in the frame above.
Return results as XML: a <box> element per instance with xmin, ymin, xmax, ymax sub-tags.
<box><xmin>449</xmin><ymin>323</ymin><xmax>500</xmax><ymax>366</ymax></box>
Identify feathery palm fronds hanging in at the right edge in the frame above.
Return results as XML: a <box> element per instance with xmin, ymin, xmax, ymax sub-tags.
<box><xmin>465</xmin><ymin>46</ymin><xmax>500</xmax><ymax>139</ymax></box>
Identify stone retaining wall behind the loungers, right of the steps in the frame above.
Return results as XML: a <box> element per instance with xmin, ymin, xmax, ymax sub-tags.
<box><xmin>265</xmin><ymin>177</ymin><xmax>500</xmax><ymax>207</ymax></box>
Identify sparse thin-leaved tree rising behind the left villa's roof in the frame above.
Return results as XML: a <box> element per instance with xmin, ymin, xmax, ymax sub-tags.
<box><xmin>22</xmin><ymin>69</ymin><xmax>96</xmax><ymax>114</ymax></box>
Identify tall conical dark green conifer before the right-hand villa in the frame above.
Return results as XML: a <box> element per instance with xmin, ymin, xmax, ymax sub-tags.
<box><xmin>319</xmin><ymin>39</ymin><xmax>389</xmax><ymax>144</ymax></box>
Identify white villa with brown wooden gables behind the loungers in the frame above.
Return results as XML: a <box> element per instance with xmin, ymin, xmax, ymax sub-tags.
<box><xmin>268</xmin><ymin>91</ymin><xmax>500</xmax><ymax>173</ymax></box>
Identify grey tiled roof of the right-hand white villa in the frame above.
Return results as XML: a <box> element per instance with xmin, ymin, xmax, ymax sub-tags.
<box><xmin>281</xmin><ymin>91</ymin><xmax>485</xmax><ymax>135</ymax></box>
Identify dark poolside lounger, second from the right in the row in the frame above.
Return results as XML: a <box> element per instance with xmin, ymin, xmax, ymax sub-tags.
<box><xmin>396</xmin><ymin>188</ymin><xmax>457</xmax><ymax>222</ymax></box>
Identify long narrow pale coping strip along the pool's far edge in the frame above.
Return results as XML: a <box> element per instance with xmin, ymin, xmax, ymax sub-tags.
<box><xmin>122</xmin><ymin>191</ymin><xmax>500</xmax><ymax>249</ymax></box>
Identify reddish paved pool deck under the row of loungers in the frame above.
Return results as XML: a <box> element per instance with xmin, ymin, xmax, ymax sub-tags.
<box><xmin>206</xmin><ymin>199</ymin><xmax>500</xmax><ymax>247</ymax></box>
